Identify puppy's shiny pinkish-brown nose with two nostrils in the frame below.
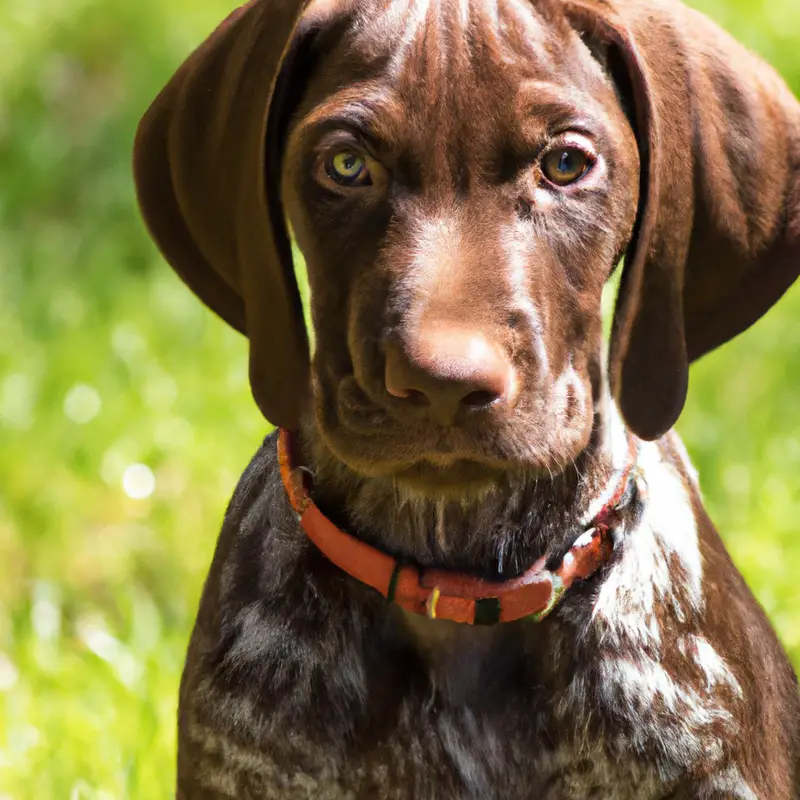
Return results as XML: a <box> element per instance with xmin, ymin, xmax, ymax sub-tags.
<box><xmin>385</xmin><ymin>327</ymin><xmax>514</xmax><ymax>425</ymax></box>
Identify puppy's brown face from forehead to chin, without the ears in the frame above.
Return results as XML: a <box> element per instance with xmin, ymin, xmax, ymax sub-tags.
<box><xmin>283</xmin><ymin>2</ymin><xmax>639</xmax><ymax>493</ymax></box>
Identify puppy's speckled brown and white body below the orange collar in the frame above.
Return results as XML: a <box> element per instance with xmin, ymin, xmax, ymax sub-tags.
<box><xmin>178</xmin><ymin>435</ymin><xmax>797</xmax><ymax>800</ymax></box>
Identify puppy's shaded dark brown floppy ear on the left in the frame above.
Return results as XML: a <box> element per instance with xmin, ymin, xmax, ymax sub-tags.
<box><xmin>134</xmin><ymin>0</ymin><xmax>347</xmax><ymax>428</ymax></box>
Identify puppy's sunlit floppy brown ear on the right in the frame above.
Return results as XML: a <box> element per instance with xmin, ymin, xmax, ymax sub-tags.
<box><xmin>566</xmin><ymin>0</ymin><xmax>800</xmax><ymax>439</ymax></box>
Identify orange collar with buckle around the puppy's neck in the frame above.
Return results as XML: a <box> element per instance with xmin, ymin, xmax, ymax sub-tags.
<box><xmin>278</xmin><ymin>429</ymin><xmax>637</xmax><ymax>625</ymax></box>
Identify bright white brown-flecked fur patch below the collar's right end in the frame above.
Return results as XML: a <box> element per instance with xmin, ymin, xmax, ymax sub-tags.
<box><xmin>558</xmin><ymin>437</ymin><xmax>748</xmax><ymax>780</ymax></box>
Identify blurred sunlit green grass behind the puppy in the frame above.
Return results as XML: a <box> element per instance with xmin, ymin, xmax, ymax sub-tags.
<box><xmin>0</xmin><ymin>0</ymin><xmax>800</xmax><ymax>800</ymax></box>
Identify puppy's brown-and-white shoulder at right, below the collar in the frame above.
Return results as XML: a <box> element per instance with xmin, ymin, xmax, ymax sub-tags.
<box><xmin>559</xmin><ymin>432</ymin><xmax>798</xmax><ymax>798</ymax></box>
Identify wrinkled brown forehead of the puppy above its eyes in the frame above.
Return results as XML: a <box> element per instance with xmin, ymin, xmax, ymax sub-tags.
<box><xmin>300</xmin><ymin>0</ymin><xmax>609</xmax><ymax>135</ymax></box>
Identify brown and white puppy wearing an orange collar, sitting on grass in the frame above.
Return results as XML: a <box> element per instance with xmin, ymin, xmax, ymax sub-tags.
<box><xmin>134</xmin><ymin>0</ymin><xmax>800</xmax><ymax>800</ymax></box>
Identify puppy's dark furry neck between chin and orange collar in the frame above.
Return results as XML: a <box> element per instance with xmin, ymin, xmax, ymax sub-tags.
<box><xmin>302</xmin><ymin>390</ymin><xmax>628</xmax><ymax>579</ymax></box>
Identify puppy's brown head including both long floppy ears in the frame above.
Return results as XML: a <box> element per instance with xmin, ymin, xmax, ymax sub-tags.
<box><xmin>136</xmin><ymin>0</ymin><xmax>800</xmax><ymax>489</ymax></box>
